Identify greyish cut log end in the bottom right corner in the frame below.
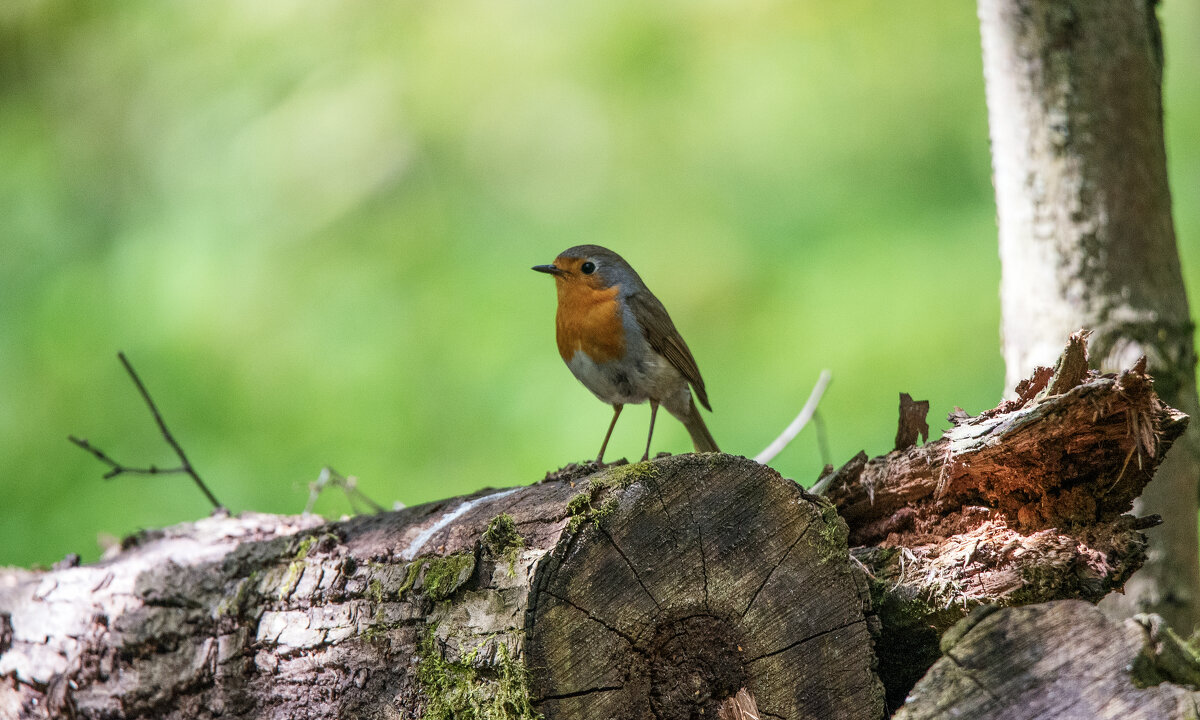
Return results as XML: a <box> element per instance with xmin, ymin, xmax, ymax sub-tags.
<box><xmin>895</xmin><ymin>600</ymin><xmax>1200</xmax><ymax>720</ymax></box>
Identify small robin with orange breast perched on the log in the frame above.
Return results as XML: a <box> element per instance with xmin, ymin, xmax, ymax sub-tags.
<box><xmin>533</xmin><ymin>245</ymin><xmax>718</xmax><ymax>463</ymax></box>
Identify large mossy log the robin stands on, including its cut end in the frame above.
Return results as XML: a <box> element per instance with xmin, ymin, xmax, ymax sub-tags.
<box><xmin>0</xmin><ymin>454</ymin><xmax>883</xmax><ymax>720</ymax></box>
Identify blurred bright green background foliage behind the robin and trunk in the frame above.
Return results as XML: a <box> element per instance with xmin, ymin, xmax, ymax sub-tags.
<box><xmin>0</xmin><ymin>0</ymin><xmax>1200</xmax><ymax>565</ymax></box>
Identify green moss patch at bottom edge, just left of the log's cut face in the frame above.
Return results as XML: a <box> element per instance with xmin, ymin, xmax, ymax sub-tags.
<box><xmin>416</xmin><ymin>626</ymin><xmax>541</xmax><ymax>720</ymax></box>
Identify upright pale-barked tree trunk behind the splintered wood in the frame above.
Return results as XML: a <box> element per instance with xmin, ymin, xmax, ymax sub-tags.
<box><xmin>979</xmin><ymin>0</ymin><xmax>1200</xmax><ymax>631</ymax></box>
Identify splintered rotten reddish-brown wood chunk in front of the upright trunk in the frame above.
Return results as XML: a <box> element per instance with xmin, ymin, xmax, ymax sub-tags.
<box><xmin>814</xmin><ymin>336</ymin><xmax>1187</xmax><ymax>707</ymax></box>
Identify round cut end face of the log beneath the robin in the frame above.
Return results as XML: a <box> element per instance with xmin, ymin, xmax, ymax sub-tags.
<box><xmin>526</xmin><ymin>455</ymin><xmax>883</xmax><ymax>720</ymax></box>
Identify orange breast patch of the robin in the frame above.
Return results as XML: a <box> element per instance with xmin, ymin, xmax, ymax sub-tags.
<box><xmin>556</xmin><ymin>282</ymin><xmax>625</xmax><ymax>362</ymax></box>
